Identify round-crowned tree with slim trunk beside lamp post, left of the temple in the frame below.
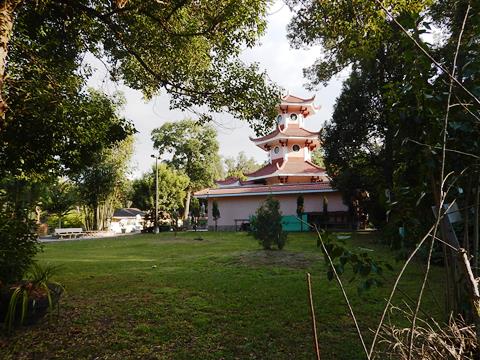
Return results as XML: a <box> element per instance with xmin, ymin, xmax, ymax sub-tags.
<box><xmin>152</xmin><ymin>119</ymin><xmax>220</xmax><ymax>219</ymax></box>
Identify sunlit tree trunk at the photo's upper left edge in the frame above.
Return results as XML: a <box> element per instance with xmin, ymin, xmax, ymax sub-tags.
<box><xmin>0</xmin><ymin>0</ymin><xmax>23</xmax><ymax>122</ymax></box>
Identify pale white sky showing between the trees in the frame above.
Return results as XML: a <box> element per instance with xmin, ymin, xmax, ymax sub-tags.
<box><xmin>90</xmin><ymin>1</ymin><xmax>345</xmax><ymax>178</ymax></box>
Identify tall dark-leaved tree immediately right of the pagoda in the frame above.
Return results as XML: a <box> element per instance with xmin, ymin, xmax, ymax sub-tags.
<box><xmin>289</xmin><ymin>0</ymin><xmax>440</xmax><ymax>235</ymax></box>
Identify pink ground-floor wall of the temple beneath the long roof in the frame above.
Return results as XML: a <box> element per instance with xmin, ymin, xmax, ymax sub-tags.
<box><xmin>208</xmin><ymin>192</ymin><xmax>348</xmax><ymax>227</ymax></box>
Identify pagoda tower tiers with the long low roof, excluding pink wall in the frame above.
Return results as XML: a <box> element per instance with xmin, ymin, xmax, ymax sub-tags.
<box><xmin>195</xmin><ymin>95</ymin><xmax>332</xmax><ymax>198</ymax></box>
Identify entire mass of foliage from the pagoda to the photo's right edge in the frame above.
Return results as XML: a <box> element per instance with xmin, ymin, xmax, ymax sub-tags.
<box><xmin>289</xmin><ymin>0</ymin><xmax>480</xmax><ymax>253</ymax></box>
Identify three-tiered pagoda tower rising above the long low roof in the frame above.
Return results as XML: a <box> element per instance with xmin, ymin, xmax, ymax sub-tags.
<box><xmin>245</xmin><ymin>95</ymin><xmax>328</xmax><ymax>185</ymax></box>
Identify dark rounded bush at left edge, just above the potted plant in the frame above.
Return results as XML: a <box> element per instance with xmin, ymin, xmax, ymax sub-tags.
<box><xmin>0</xmin><ymin>202</ymin><xmax>40</xmax><ymax>285</ymax></box>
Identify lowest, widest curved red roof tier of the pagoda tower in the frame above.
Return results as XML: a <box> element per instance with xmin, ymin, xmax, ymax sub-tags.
<box><xmin>245</xmin><ymin>158</ymin><xmax>325</xmax><ymax>178</ymax></box>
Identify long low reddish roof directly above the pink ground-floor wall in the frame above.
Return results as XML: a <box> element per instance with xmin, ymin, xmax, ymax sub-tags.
<box><xmin>193</xmin><ymin>182</ymin><xmax>333</xmax><ymax>198</ymax></box>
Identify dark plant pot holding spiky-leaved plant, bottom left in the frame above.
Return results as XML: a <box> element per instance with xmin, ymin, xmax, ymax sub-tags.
<box><xmin>0</xmin><ymin>284</ymin><xmax>63</xmax><ymax>325</ymax></box>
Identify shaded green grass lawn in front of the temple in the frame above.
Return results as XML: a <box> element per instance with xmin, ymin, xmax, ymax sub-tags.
<box><xmin>0</xmin><ymin>233</ymin><xmax>443</xmax><ymax>360</ymax></box>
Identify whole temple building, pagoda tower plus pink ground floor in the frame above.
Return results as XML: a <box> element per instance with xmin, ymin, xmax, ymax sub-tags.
<box><xmin>194</xmin><ymin>95</ymin><xmax>348</xmax><ymax>231</ymax></box>
